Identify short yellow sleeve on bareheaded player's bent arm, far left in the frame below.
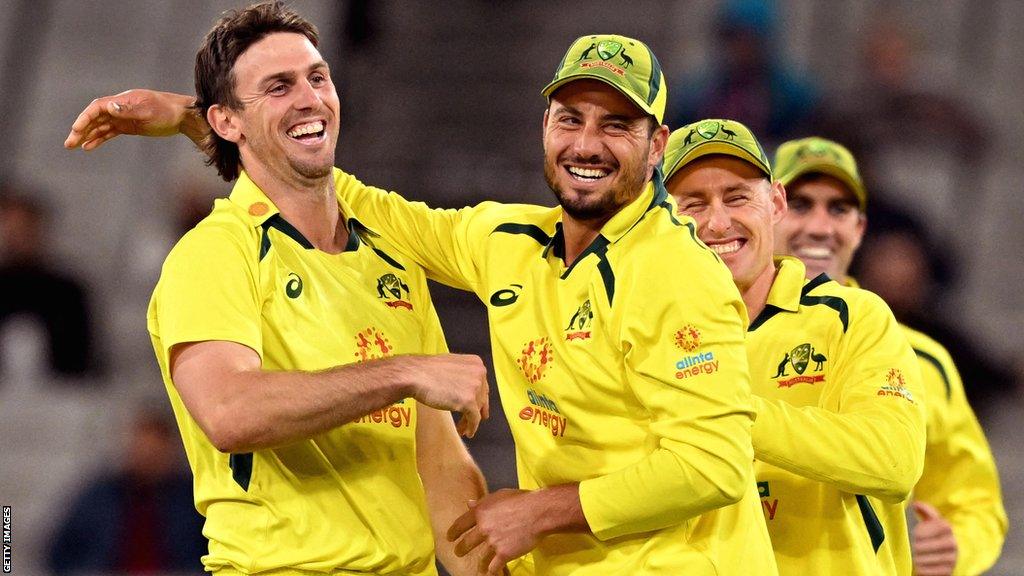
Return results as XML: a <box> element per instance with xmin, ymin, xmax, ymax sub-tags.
<box><xmin>151</xmin><ymin>225</ymin><xmax>263</xmax><ymax>360</ymax></box>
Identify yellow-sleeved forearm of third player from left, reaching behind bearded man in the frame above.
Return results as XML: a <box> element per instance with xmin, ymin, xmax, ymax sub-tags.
<box><xmin>753</xmin><ymin>397</ymin><xmax>925</xmax><ymax>501</ymax></box>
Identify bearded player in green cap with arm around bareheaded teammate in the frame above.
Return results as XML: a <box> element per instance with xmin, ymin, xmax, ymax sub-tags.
<box><xmin>69</xmin><ymin>35</ymin><xmax>776</xmax><ymax>576</ymax></box>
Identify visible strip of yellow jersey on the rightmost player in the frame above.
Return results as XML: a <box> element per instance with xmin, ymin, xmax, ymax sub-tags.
<box><xmin>903</xmin><ymin>326</ymin><xmax>1007</xmax><ymax>576</ymax></box>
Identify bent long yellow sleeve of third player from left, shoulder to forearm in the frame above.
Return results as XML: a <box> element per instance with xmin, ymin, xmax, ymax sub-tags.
<box><xmin>754</xmin><ymin>292</ymin><xmax>926</xmax><ymax>501</ymax></box>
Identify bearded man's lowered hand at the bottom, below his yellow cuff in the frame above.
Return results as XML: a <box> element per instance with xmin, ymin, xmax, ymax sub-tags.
<box><xmin>447</xmin><ymin>489</ymin><xmax>541</xmax><ymax>576</ymax></box>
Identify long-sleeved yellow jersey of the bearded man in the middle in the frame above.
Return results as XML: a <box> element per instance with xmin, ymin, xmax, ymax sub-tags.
<box><xmin>337</xmin><ymin>168</ymin><xmax>775</xmax><ymax>576</ymax></box>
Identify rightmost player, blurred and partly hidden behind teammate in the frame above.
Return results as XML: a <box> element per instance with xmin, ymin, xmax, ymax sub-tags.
<box><xmin>775</xmin><ymin>137</ymin><xmax>1008</xmax><ymax>576</ymax></box>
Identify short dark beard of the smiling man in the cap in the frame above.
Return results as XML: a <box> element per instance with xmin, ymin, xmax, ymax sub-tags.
<box><xmin>544</xmin><ymin>147</ymin><xmax>650</xmax><ymax>220</ymax></box>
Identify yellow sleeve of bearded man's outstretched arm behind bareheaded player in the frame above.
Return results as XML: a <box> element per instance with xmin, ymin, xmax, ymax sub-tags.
<box><xmin>335</xmin><ymin>166</ymin><xmax>494</xmax><ymax>292</ymax></box>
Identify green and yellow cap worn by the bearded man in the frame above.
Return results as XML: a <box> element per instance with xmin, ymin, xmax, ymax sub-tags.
<box><xmin>542</xmin><ymin>34</ymin><xmax>667</xmax><ymax>124</ymax></box>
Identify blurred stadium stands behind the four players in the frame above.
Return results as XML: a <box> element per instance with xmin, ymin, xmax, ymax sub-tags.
<box><xmin>0</xmin><ymin>0</ymin><xmax>1024</xmax><ymax>575</ymax></box>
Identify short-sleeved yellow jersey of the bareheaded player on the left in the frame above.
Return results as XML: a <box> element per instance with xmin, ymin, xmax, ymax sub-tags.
<box><xmin>148</xmin><ymin>173</ymin><xmax>445</xmax><ymax>575</ymax></box>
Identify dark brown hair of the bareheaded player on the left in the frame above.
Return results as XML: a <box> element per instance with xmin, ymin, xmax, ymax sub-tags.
<box><xmin>196</xmin><ymin>1</ymin><xmax>319</xmax><ymax>181</ymax></box>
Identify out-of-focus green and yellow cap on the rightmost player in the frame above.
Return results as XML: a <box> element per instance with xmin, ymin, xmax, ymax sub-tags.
<box><xmin>775</xmin><ymin>136</ymin><xmax>867</xmax><ymax>211</ymax></box>
